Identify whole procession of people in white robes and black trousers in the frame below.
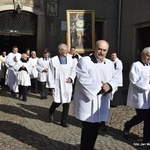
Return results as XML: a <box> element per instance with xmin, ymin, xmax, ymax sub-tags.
<box><xmin>0</xmin><ymin>40</ymin><xmax>150</xmax><ymax>150</ymax></box>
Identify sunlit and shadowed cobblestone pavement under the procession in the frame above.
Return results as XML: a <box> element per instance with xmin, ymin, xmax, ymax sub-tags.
<box><xmin>0</xmin><ymin>89</ymin><xmax>150</xmax><ymax>150</ymax></box>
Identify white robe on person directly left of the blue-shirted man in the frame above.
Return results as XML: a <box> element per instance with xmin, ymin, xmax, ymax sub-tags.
<box><xmin>37</xmin><ymin>57</ymin><xmax>51</xmax><ymax>82</ymax></box>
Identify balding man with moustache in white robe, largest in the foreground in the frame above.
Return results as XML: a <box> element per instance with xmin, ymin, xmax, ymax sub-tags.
<box><xmin>73</xmin><ymin>40</ymin><xmax>120</xmax><ymax>150</ymax></box>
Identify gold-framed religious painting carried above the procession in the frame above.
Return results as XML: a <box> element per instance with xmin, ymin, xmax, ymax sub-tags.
<box><xmin>67</xmin><ymin>10</ymin><xmax>95</xmax><ymax>54</ymax></box>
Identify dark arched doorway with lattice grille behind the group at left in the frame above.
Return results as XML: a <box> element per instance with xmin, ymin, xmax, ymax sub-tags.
<box><xmin>0</xmin><ymin>11</ymin><xmax>37</xmax><ymax>53</ymax></box>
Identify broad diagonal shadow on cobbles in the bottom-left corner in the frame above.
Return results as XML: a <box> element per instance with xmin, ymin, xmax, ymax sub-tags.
<box><xmin>0</xmin><ymin>121</ymin><xmax>77</xmax><ymax>150</ymax></box>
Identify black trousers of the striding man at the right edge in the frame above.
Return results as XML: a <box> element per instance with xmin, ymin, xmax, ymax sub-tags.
<box><xmin>125</xmin><ymin>109</ymin><xmax>150</xmax><ymax>141</ymax></box>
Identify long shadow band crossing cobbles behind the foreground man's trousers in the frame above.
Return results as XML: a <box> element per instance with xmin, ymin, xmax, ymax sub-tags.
<box><xmin>0</xmin><ymin>104</ymin><xmax>147</xmax><ymax>150</ymax></box>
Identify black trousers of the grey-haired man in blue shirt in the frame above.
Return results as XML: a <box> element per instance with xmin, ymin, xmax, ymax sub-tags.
<box><xmin>49</xmin><ymin>102</ymin><xmax>69</xmax><ymax>123</ymax></box>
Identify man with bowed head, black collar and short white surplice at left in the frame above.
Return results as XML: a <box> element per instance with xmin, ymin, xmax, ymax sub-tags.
<box><xmin>14</xmin><ymin>53</ymin><xmax>32</xmax><ymax>101</ymax></box>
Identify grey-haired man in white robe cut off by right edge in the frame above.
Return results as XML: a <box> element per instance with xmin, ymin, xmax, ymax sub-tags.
<box><xmin>124</xmin><ymin>47</ymin><xmax>150</xmax><ymax>142</ymax></box>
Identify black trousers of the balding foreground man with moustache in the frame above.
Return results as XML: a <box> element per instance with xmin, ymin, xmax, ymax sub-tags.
<box><xmin>80</xmin><ymin>121</ymin><xmax>100</xmax><ymax>150</ymax></box>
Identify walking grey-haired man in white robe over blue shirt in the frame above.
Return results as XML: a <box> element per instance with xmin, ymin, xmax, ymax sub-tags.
<box><xmin>47</xmin><ymin>44</ymin><xmax>76</xmax><ymax>127</ymax></box>
